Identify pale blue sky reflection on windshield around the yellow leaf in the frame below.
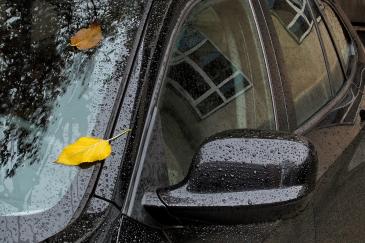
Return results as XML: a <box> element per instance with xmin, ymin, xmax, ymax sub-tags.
<box><xmin>0</xmin><ymin>54</ymin><xmax>103</xmax><ymax>215</ymax></box>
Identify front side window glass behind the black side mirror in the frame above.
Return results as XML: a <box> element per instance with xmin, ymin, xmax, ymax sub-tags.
<box><xmin>130</xmin><ymin>0</ymin><xmax>276</xmax><ymax>225</ymax></box>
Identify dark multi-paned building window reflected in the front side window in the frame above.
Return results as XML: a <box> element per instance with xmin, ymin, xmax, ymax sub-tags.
<box><xmin>168</xmin><ymin>27</ymin><xmax>251</xmax><ymax>119</ymax></box>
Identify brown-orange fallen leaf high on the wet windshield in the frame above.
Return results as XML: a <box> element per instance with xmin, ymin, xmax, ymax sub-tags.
<box><xmin>70</xmin><ymin>23</ymin><xmax>103</xmax><ymax>50</ymax></box>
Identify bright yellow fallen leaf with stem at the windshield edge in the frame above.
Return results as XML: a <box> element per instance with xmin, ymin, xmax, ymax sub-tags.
<box><xmin>56</xmin><ymin>129</ymin><xmax>131</xmax><ymax>165</ymax></box>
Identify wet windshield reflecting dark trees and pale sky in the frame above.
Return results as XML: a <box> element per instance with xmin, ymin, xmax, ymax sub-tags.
<box><xmin>0</xmin><ymin>0</ymin><xmax>137</xmax><ymax>216</ymax></box>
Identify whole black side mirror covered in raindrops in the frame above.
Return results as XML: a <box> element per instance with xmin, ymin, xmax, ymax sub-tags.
<box><xmin>143</xmin><ymin>130</ymin><xmax>318</xmax><ymax>224</ymax></box>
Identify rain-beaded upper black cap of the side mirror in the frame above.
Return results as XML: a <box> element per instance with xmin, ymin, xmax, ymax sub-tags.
<box><xmin>187</xmin><ymin>129</ymin><xmax>318</xmax><ymax>193</ymax></box>
